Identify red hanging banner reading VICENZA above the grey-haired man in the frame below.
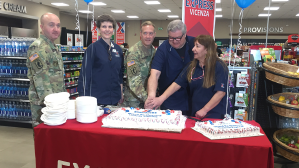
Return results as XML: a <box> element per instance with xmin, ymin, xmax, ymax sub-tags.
<box><xmin>182</xmin><ymin>0</ymin><xmax>216</xmax><ymax>37</ymax></box>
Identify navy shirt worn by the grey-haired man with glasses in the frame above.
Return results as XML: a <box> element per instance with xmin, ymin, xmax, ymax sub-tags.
<box><xmin>151</xmin><ymin>36</ymin><xmax>194</xmax><ymax>111</ymax></box>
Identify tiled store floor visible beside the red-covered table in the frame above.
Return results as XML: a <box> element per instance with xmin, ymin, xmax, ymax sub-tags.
<box><xmin>0</xmin><ymin>126</ymin><xmax>299</xmax><ymax>168</ymax></box>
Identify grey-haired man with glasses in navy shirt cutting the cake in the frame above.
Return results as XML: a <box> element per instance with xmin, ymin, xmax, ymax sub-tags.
<box><xmin>145</xmin><ymin>20</ymin><xmax>194</xmax><ymax>115</ymax></box>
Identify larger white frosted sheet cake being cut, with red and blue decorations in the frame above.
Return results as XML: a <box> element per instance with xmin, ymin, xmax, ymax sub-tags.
<box><xmin>102</xmin><ymin>107</ymin><xmax>186</xmax><ymax>132</ymax></box>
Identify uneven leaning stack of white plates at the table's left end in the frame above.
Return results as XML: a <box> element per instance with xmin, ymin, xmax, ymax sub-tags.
<box><xmin>41</xmin><ymin>92</ymin><xmax>70</xmax><ymax>125</ymax></box>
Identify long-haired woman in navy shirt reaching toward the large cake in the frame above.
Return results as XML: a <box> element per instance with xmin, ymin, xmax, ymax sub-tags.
<box><xmin>150</xmin><ymin>35</ymin><xmax>229</xmax><ymax>119</ymax></box>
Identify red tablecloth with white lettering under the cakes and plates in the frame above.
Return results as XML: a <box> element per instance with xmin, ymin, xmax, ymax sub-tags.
<box><xmin>34</xmin><ymin>117</ymin><xmax>274</xmax><ymax>168</ymax></box>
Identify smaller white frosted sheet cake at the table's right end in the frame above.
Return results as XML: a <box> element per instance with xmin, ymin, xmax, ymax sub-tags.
<box><xmin>192</xmin><ymin>119</ymin><xmax>263</xmax><ymax>139</ymax></box>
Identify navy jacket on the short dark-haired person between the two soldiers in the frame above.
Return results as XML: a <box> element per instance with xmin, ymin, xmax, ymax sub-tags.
<box><xmin>78</xmin><ymin>38</ymin><xmax>124</xmax><ymax>105</ymax></box>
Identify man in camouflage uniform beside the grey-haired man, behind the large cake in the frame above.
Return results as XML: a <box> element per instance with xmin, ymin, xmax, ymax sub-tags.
<box><xmin>123</xmin><ymin>21</ymin><xmax>156</xmax><ymax>108</ymax></box>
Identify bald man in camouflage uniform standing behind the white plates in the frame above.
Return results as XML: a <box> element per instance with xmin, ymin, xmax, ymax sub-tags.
<box><xmin>26</xmin><ymin>13</ymin><xmax>66</xmax><ymax>127</ymax></box>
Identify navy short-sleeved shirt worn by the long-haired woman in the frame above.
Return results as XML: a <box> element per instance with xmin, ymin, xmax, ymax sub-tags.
<box><xmin>175</xmin><ymin>61</ymin><xmax>230</xmax><ymax>118</ymax></box>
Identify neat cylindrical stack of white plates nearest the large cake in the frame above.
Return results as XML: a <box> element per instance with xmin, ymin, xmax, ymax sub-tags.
<box><xmin>76</xmin><ymin>96</ymin><xmax>98</xmax><ymax>123</ymax></box>
